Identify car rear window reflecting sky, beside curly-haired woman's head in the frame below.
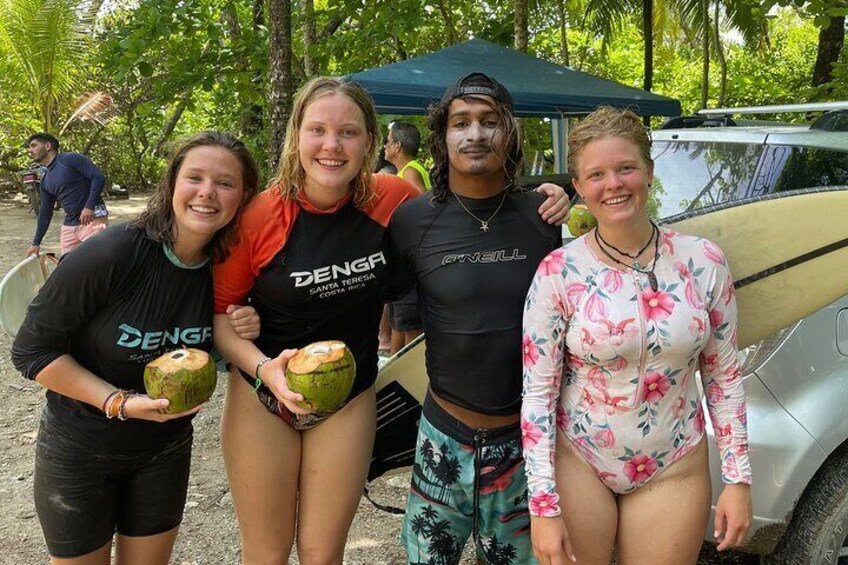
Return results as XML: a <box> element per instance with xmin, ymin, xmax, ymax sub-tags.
<box><xmin>648</xmin><ymin>140</ymin><xmax>764</xmax><ymax>219</ymax></box>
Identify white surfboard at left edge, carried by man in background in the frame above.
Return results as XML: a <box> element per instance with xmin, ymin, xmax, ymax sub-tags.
<box><xmin>0</xmin><ymin>255</ymin><xmax>57</xmax><ymax>337</ymax></box>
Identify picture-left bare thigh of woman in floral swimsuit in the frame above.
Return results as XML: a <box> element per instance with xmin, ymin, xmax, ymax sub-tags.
<box><xmin>556</xmin><ymin>434</ymin><xmax>620</xmax><ymax>565</ymax></box>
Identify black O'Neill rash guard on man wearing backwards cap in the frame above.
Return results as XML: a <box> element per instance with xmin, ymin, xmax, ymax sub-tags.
<box><xmin>389</xmin><ymin>192</ymin><xmax>562</xmax><ymax>415</ymax></box>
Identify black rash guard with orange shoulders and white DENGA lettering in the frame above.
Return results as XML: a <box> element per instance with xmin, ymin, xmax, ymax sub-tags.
<box><xmin>215</xmin><ymin>175</ymin><xmax>418</xmax><ymax>399</ymax></box>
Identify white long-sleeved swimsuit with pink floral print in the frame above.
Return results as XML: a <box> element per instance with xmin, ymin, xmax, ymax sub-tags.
<box><xmin>521</xmin><ymin>228</ymin><xmax>751</xmax><ymax>516</ymax></box>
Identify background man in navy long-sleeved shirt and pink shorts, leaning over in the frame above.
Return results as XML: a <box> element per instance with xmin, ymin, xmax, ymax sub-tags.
<box><xmin>26</xmin><ymin>133</ymin><xmax>109</xmax><ymax>257</ymax></box>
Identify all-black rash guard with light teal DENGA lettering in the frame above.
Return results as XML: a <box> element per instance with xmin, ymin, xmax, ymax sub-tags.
<box><xmin>12</xmin><ymin>225</ymin><xmax>212</xmax><ymax>451</ymax></box>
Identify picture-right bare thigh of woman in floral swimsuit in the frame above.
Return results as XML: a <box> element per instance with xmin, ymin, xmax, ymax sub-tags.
<box><xmin>616</xmin><ymin>439</ymin><xmax>711</xmax><ymax>565</ymax></box>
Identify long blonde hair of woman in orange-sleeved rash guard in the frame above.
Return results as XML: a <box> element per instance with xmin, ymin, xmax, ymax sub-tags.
<box><xmin>269</xmin><ymin>77</ymin><xmax>380</xmax><ymax>208</ymax></box>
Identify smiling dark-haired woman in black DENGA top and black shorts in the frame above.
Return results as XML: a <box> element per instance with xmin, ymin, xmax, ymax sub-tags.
<box><xmin>12</xmin><ymin>132</ymin><xmax>258</xmax><ymax>565</ymax></box>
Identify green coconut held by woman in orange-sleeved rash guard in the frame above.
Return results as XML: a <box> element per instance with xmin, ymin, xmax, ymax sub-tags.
<box><xmin>286</xmin><ymin>341</ymin><xmax>356</xmax><ymax>412</ymax></box>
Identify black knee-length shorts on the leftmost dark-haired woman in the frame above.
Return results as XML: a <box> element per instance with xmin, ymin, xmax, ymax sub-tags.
<box><xmin>35</xmin><ymin>408</ymin><xmax>192</xmax><ymax>558</ymax></box>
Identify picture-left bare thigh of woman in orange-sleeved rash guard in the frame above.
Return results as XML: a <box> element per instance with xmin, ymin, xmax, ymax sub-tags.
<box><xmin>221</xmin><ymin>372</ymin><xmax>301</xmax><ymax>565</ymax></box>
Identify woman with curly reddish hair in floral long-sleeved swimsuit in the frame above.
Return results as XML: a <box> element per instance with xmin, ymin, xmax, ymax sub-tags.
<box><xmin>521</xmin><ymin>108</ymin><xmax>751</xmax><ymax>565</ymax></box>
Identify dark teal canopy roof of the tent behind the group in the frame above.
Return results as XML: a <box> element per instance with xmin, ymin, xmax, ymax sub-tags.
<box><xmin>349</xmin><ymin>39</ymin><xmax>681</xmax><ymax>118</ymax></box>
